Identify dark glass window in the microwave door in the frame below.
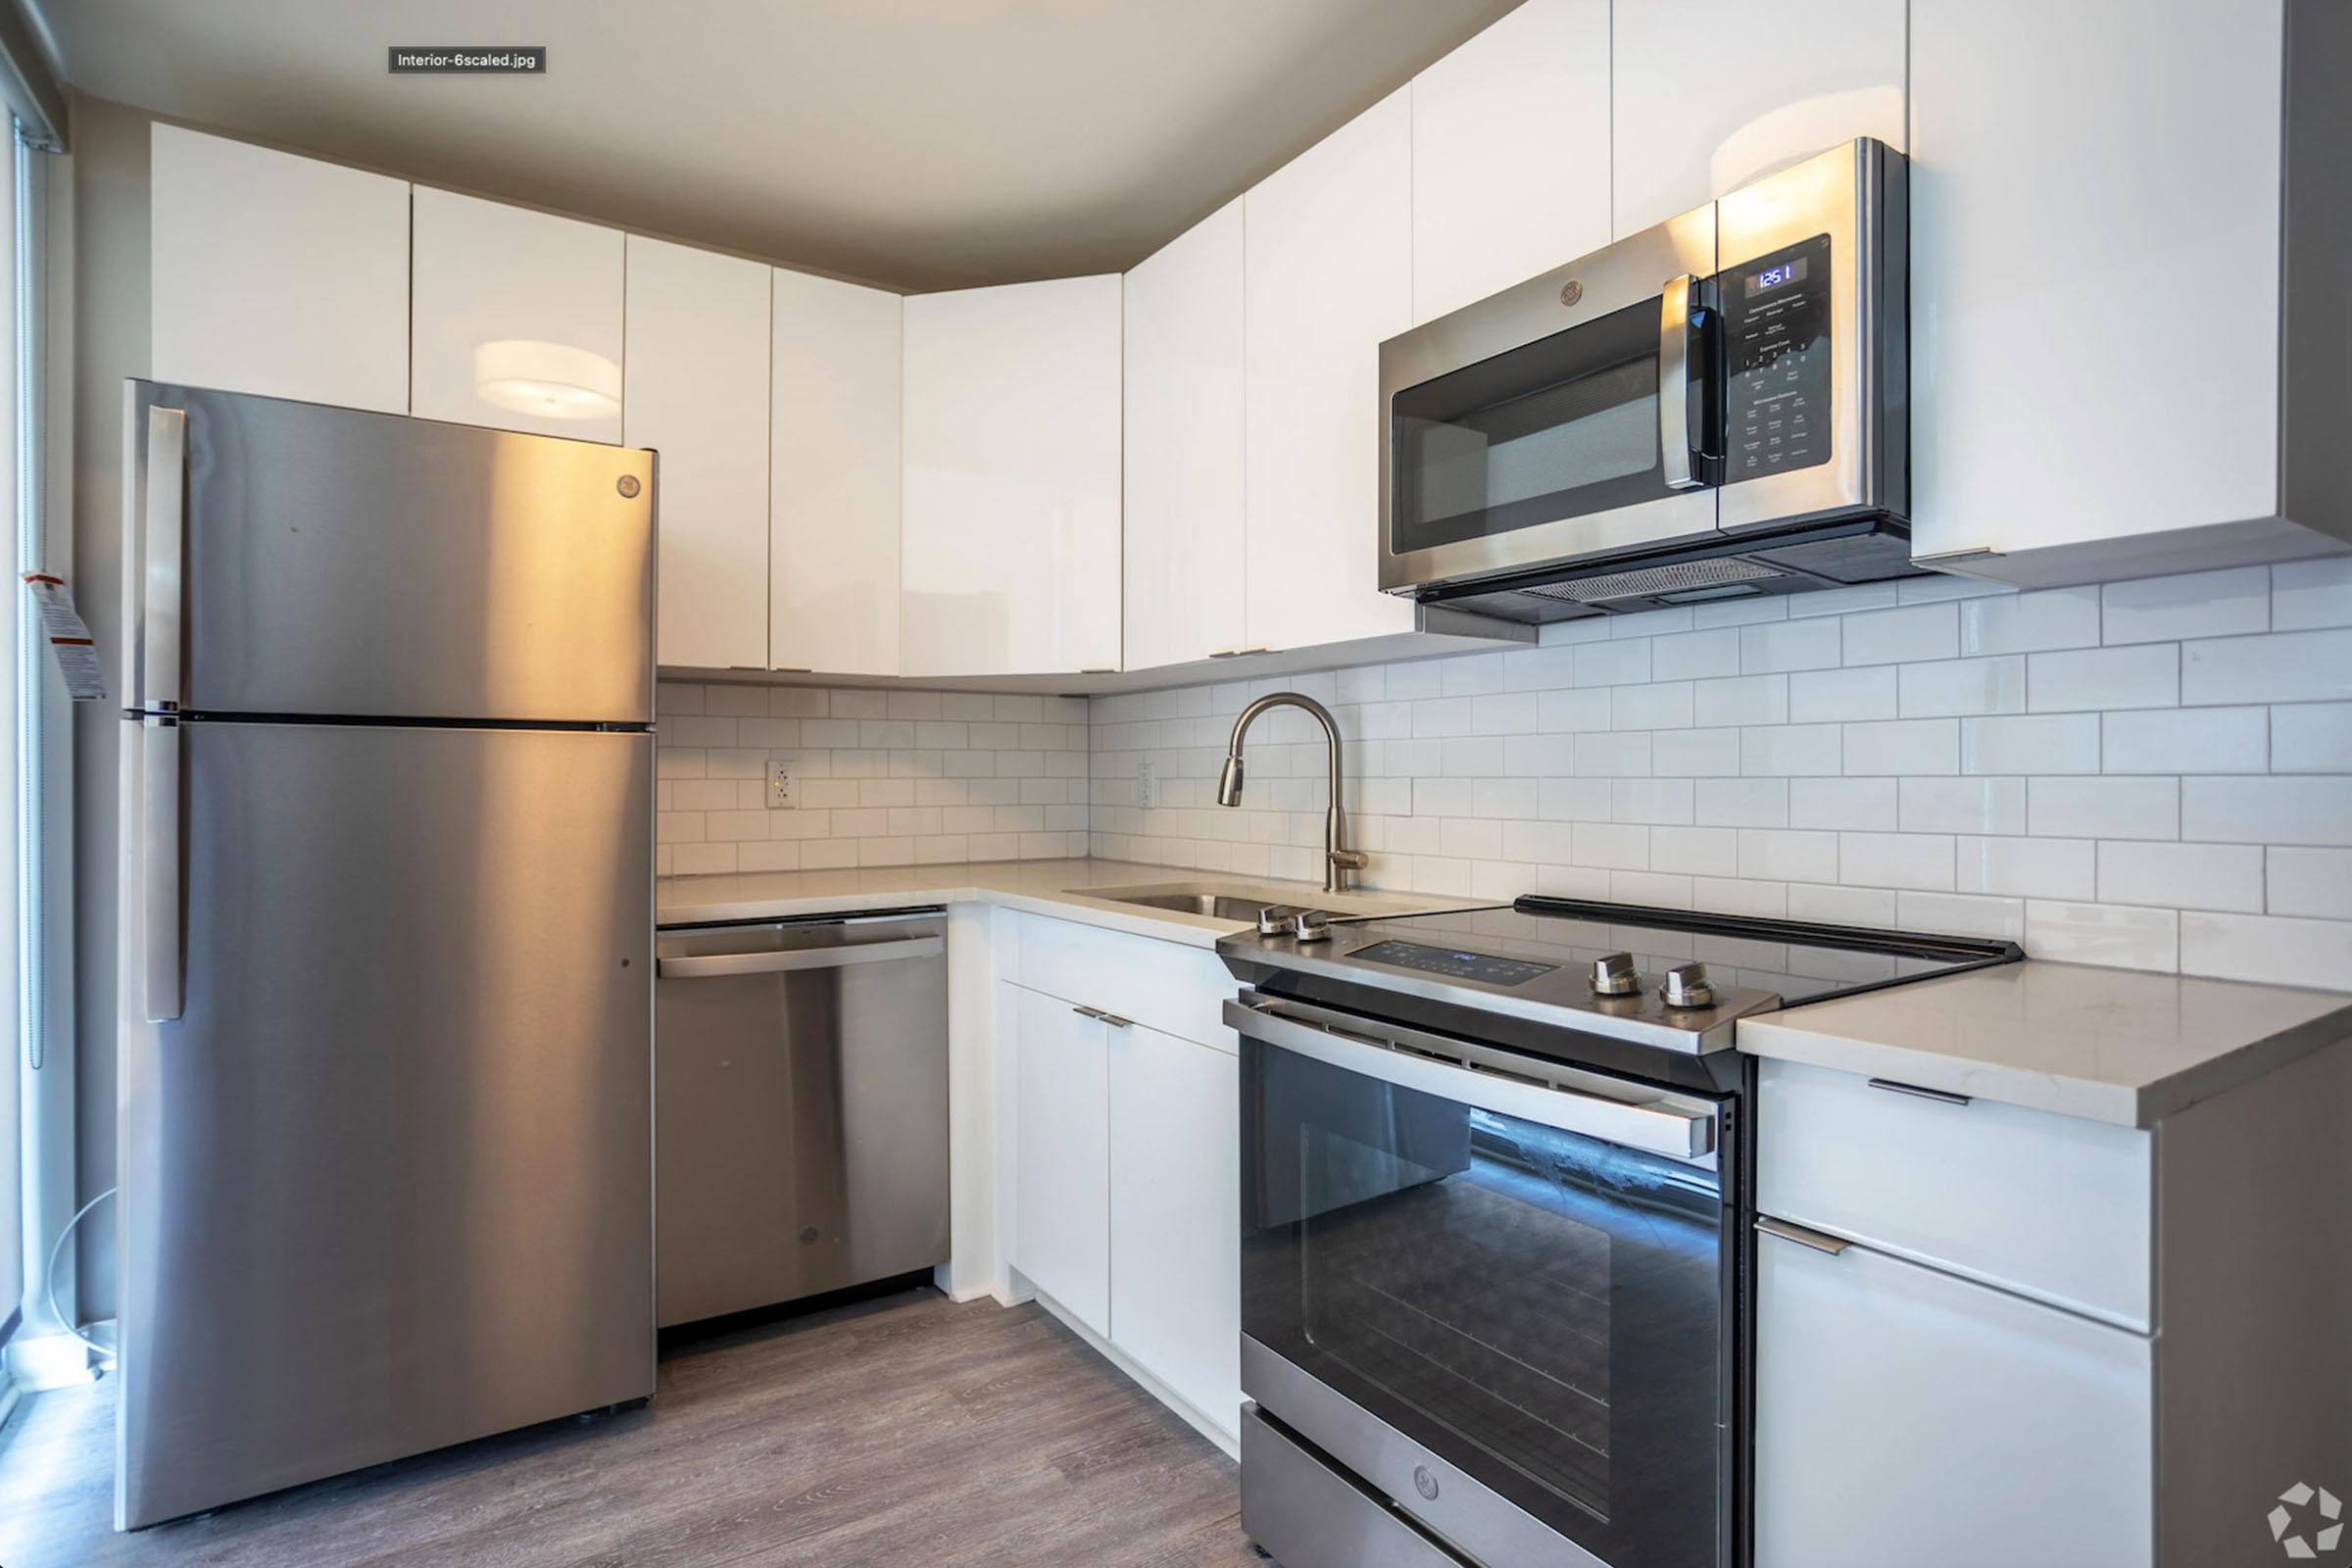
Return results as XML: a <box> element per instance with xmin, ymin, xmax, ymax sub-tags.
<box><xmin>1390</xmin><ymin>299</ymin><xmax>1672</xmax><ymax>555</ymax></box>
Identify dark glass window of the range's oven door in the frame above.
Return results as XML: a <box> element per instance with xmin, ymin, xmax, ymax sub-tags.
<box><xmin>1242</xmin><ymin>1037</ymin><xmax>1731</xmax><ymax>1568</ymax></box>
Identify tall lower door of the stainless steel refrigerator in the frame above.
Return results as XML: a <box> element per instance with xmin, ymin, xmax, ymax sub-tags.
<box><xmin>118</xmin><ymin>721</ymin><xmax>654</xmax><ymax>1526</ymax></box>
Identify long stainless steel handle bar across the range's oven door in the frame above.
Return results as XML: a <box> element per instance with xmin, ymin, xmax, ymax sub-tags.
<box><xmin>1225</xmin><ymin>999</ymin><xmax>1715</xmax><ymax>1163</ymax></box>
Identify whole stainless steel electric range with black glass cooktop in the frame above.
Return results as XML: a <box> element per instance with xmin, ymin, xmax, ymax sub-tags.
<box><xmin>1218</xmin><ymin>898</ymin><xmax>2021</xmax><ymax>1568</ymax></box>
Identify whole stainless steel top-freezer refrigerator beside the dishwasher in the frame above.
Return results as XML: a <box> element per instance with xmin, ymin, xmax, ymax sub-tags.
<box><xmin>116</xmin><ymin>383</ymin><xmax>654</xmax><ymax>1528</ymax></box>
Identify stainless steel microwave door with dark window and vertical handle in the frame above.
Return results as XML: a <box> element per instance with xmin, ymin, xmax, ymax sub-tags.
<box><xmin>1381</xmin><ymin>207</ymin><xmax>1722</xmax><ymax>590</ymax></box>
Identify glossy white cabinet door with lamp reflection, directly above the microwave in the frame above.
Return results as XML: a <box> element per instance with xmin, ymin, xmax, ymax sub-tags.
<box><xmin>1611</xmin><ymin>0</ymin><xmax>1900</xmax><ymax>237</ymax></box>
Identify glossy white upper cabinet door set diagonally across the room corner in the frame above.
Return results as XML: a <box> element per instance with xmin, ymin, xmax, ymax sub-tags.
<box><xmin>901</xmin><ymin>275</ymin><xmax>1119</xmax><ymax>674</ymax></box>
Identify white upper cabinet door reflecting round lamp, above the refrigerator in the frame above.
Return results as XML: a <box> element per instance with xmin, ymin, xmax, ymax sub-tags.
<box><xmin>410</xmin><ymin>186</ymin><xmax>623</xmax><ymax>442</ymax></box>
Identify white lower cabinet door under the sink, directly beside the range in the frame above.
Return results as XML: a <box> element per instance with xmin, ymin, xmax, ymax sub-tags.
<box><xmin>1107</xmin><ymin>1025</ymin><xmax>1242</xmax><ymax>1439</ymax></box>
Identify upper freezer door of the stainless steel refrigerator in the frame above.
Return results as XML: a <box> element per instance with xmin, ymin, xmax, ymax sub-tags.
<box><xmin>124</xmin><ymin>383</ymin><xmax>654</xmax><ymax>724</ymax></box>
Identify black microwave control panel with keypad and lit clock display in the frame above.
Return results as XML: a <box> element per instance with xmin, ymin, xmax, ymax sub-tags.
<box><xmin>1717</xmin><ymin>235</ymin><xmax>1830</xmax><ymax>484</ymax></box>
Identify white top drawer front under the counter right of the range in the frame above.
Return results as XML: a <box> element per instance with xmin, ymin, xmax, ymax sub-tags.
<box><xmin>1757</xmin><ymin>1062</ymin><xmax>2152</xmax><ymax>1331</ymax></box>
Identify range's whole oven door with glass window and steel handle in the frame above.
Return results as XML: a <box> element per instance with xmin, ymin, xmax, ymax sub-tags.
<box><xmin>1225</xmin><ymin>992</ymin><xmax>1739</xmax><ymax>1568</ymax></box>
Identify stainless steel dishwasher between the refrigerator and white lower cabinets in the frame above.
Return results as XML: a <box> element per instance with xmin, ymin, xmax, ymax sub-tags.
<box><xmin>654</xmin><ymin>909</ymin><xmax>948</xmax><ymax>1326</ymax></box>
